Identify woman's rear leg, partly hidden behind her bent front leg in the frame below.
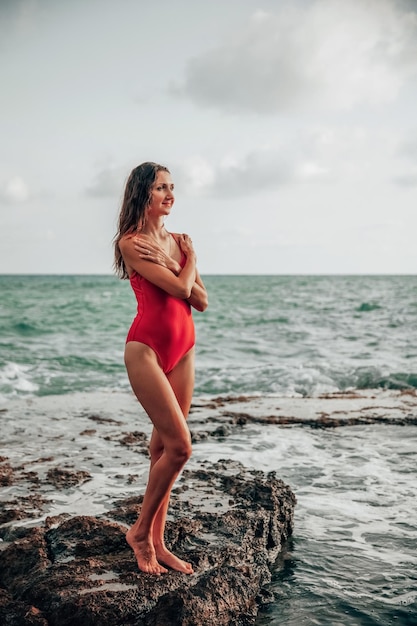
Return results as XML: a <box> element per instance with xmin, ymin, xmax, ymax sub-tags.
<box><xmin>150</xmin><ymin>348</ymin><xmax>194</xmax><ymax>574</ymax></box>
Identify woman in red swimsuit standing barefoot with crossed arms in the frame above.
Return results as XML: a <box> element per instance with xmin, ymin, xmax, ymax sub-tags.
<box><xmin>115</xmin><ymin>162</ymin><xmax>207</xmax><ymax>575</ymax></box>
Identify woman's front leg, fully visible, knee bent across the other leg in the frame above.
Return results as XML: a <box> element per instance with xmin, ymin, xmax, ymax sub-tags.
<box><xmin>125</xmin><ymin>342</ymin><xmax>191</xmax><ymax>574</ymax></box>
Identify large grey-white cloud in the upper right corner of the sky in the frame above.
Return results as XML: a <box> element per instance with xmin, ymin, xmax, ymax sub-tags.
<box><xmin>172</xmin><ymin>0</ymin><xmax>417</xmax><ymax>114</ymax></box>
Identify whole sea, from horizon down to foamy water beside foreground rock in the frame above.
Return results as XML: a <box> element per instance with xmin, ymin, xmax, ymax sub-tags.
<box><xmin>0</xmin><ymin>275</ymin><xmax>417</xmax><ymax>626</ymax></box>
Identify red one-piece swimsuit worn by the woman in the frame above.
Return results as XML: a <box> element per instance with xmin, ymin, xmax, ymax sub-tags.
<box><xmin>126</xmin><ymin>243</ymin><xmax>195</xmax><ymax>374</ymax></box>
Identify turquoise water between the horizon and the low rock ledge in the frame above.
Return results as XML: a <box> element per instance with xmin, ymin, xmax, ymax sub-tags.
<box><xmin>0</xmin><ymin>276</ymin><xmax>417</xmax><ymax>397</ymax></box>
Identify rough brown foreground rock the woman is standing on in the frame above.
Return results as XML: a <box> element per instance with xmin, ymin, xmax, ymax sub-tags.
<box><xmin>0</xmin><ymin>461</ymin><xmax>296</xmax><ymax>626</ymax></box>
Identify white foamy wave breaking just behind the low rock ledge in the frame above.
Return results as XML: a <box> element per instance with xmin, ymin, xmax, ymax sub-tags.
<box><xmin>0</xmin><ymin>355</ymin><xmax>417</xmax><ymax>397</ymax></box>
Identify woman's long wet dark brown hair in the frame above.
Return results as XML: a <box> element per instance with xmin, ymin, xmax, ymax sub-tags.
<box><xmin>114</xmin><ymin>161</ymin><xmax>170</xmax><ymax>278</ymax></box>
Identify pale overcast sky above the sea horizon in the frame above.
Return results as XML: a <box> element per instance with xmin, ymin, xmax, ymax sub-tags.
<box><xmin>0</xmin><ymin>0</ymin><xmax>417</xmax><ymax>275</ymax></box>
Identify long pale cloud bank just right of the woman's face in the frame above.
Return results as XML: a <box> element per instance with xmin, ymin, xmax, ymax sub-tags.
<box><xmin>174</xmin><ymin>126</ymin><xmax>380</xmax><ymax>198</ymax></box>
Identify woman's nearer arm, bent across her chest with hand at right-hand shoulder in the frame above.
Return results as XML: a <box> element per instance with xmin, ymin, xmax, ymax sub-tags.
<box><xmin>119</xmin><ymin>235</ymin><xmax>196</xmax><ymax>300</ymax></box>
